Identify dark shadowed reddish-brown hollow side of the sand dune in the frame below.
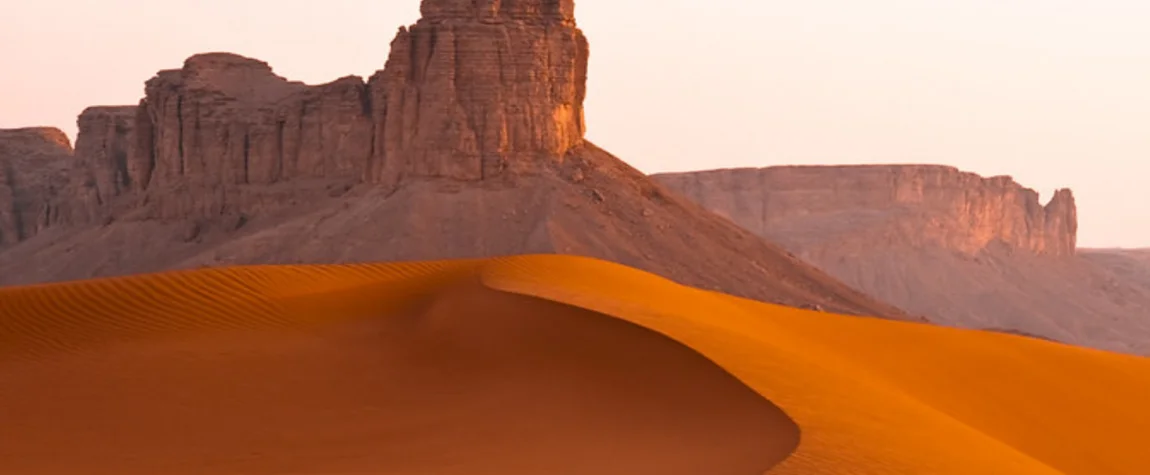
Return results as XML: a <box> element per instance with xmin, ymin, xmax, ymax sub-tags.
<box><xmin>0</xmin><ymin>277</ymin><xmax>799</xmax><ymax>475</ymax></box>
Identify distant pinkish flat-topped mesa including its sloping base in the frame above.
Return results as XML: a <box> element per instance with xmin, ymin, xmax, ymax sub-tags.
<box><xmin>654</xmin><ymin>166</ymin><xmax>1150</xmax><ymax>353</ymax></box>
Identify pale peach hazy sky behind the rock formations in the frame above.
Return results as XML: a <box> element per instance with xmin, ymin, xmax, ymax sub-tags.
<box><xmin>0</xmin><ymin>0</ymin><xmax>1150</xmax><ymax>246</ymax></box>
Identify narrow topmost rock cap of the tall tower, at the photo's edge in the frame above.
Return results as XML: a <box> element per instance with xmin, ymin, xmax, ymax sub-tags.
<box><xmin>420</xmin><ymin>0</ymin><xmax>575</xmax><ymax>24</ymax></box>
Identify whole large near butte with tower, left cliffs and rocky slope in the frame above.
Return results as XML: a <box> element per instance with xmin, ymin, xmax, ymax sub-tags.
<box><xmin>0</xmin><ymin>0</ymin><xmax>907</xmax><ymax>319</ymax></box>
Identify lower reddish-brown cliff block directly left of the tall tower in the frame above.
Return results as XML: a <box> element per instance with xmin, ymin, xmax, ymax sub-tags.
<box><xmin>129</xmin><ymin>53</ymin><xmax>371</xmax><ymax>205</ymax></box>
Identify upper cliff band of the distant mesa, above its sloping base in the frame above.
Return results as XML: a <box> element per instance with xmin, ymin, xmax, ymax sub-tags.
<box><xmin>656</xmin><ymin>166</ymin><xmax>1078</xmax><ymax>255</ymax></box>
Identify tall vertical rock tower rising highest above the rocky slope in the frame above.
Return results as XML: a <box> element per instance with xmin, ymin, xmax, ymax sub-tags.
<box><xmin>366</xmin><ymin>0</ymin><xmax>589</xmax><ymax>185</ymax></box>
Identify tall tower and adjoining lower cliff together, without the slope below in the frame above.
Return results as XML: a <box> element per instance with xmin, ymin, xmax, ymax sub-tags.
<box><xmin>115</xmin><ymin>0</ymin><xmax>588</xmax><ymax>217</ymax></box>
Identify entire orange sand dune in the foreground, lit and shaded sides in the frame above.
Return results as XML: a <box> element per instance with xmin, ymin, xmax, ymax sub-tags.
<box><xmin>0</xmin><ymin>255</ymin><xmax>1150</xmax><ymax>475</ymax></box>
